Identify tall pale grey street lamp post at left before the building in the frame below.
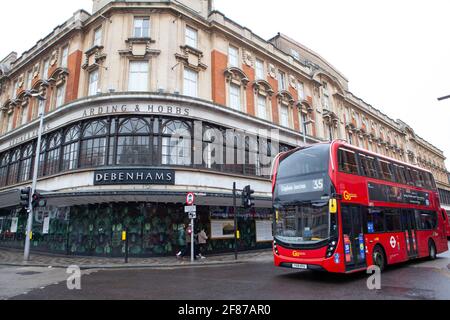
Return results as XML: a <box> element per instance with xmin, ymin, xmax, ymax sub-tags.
<box><xmin>23</xmin><ymin>93</ymin><xmax>46</xmax><ymax>261</ymax></box>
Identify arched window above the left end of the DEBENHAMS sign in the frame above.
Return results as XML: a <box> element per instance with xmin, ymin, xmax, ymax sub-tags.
<box><xmin>80</xmin><ymin>121</ymin><xmax>107</xmax><ymax>168</ymax></box>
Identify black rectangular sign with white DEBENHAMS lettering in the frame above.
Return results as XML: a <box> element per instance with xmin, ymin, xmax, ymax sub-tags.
<box><xmin>94</xmin><ymin>169</ymin><xmax>175</xmax><ymax>186</ymax></box>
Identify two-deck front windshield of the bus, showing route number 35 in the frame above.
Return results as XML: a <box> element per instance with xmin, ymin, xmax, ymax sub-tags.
<box><xmin>274</xmin><ymin>144</ymin><xmax>335</xmax><ymax>245</ymax></box>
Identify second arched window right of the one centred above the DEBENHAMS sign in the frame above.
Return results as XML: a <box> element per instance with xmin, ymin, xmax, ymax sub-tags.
<box><xmin>203</xmin><ymin>127</ymin><xmax>224</xmax><ymax>170</ymax></box>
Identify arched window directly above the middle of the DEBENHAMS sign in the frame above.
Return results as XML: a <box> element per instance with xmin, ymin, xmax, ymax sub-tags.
<box><xmin>117</xmin><ymin>118</ymin><xmax>152</xmax><ymax>165</ymax></box>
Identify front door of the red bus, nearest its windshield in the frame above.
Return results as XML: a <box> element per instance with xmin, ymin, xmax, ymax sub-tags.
<box><xmin>342</xmin><ymin>205</ymin><xmax>367</xmax><ymax>271</ymax></box>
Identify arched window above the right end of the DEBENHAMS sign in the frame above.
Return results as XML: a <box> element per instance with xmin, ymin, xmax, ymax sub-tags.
<box><xmin>162</xmin><ymin>120</ymin><xmax>192</xmax><ymax>166</ymax></box>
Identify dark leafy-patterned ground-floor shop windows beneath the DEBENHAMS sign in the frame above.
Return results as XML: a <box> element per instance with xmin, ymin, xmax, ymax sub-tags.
<box><xmin>0</xmin><ymin>203</ymin><xmax>271</xmax><ymax>257</ymax></box>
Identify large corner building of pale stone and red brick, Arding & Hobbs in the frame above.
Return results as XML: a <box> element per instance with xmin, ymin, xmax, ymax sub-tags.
<box><xmin>0</xmin><ymin>0</ymin><xmax>450</xmax><ymax>255</ymax></box>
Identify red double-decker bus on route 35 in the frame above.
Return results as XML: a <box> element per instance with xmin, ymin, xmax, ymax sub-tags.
<box><xmin>273</xmin><ymin>141</ymin><xmax>448</xmax><ymax>273</ymax></box>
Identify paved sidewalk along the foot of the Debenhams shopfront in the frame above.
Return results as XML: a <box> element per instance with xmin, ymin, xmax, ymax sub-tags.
<box><xmin>0</xmin><ymin>248</ymin><xmax>273</xmax><ymax>270</ymax></box>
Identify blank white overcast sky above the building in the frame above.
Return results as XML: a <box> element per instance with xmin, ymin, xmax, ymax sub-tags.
<box><xmin>0</xmin><ymin>0</ymin><xmax>450</xmax><ymax>169</ymax></box>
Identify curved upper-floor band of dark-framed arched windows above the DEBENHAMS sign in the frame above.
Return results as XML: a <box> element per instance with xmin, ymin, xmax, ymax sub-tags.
<box><xmin>0</xmin><ymin>116</ymin><xmax>292</xmax><ymax>188</ymax></box>
